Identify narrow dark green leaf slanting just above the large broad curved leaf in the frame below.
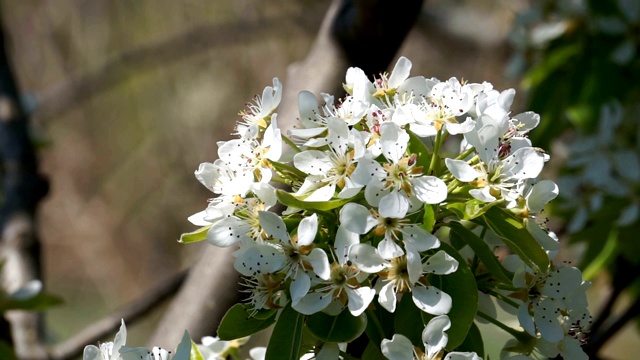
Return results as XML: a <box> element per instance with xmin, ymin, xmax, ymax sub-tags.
<box><xmin>449</xmin><ymin>221</ymin><xmax>513</xmax><ymax>284</ymax></box>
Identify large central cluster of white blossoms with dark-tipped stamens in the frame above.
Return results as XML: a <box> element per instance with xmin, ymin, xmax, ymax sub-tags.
<box><xmin>182</xmin><ymin>57</ymin><xmax>586</xmax><ymax>359</ymax></box>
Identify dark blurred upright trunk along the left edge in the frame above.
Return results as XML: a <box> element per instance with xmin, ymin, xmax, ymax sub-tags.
<box><xmin>0</xmin><ymin>16</ymin><xmax>48</xmax><ymax>359</ymax></box>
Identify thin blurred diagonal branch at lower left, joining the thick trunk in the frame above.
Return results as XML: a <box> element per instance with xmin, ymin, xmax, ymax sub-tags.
<box><xmin>49</xmin><ymin>271</ymin><xmax>187</xmax><ymax>360</ymax></box>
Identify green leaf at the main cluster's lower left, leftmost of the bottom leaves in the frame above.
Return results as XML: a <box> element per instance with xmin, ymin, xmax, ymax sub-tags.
<box><xmin>218</xmin><ymin>304</ymin><xmax>276</xmax><ymax>340</ymax></box>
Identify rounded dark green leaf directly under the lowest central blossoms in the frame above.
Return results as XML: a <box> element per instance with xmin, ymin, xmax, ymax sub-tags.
<box><xmin>307</xmin><ymin>308</ymin><xmax>367</xmax><ymax>343</ymax></box>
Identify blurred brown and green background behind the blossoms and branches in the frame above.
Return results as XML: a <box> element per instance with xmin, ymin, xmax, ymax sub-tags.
<box><xmin>0</xmin><ymin>0</ymin><xmax>640</xmax><ymax>359</ymax></box>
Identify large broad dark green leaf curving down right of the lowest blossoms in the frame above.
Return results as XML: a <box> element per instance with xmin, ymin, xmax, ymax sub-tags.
<box><xmin>422</xmin><ymin>243</ymin><xmax>478</xmax><ymax>351</ymax></box>
